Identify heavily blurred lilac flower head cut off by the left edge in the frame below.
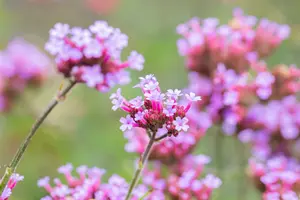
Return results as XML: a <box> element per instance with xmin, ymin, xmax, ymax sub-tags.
<box><xmin>0</xmin><ymin>38</ymin><xmax>50</xmax><ymax>112</ymax></box>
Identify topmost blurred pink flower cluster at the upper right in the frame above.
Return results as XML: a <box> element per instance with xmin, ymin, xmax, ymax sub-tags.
<box><xmin>177</xmin><ymin>9</ymin><xmax>290</xmax><ymax>77</ymax></box>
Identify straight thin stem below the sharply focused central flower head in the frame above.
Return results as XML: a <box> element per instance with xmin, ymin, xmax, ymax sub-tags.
<box><xmin>125</xmin><ymin>129</ymin><xmax>156</xmax><ymax>200</ymax></box>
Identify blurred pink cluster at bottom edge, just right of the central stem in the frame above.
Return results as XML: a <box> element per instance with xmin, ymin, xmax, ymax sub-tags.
<box><xmin>143</xmin><ymin>155</ymin><xmax>222</xmax><ymax>200</ymax></box>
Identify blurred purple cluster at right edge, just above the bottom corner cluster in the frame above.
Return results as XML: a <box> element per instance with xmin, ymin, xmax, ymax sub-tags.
<box><xmin>238</xmin><ymin>96</ymin><xmax>300</xmax><ymax>159</ymax></box>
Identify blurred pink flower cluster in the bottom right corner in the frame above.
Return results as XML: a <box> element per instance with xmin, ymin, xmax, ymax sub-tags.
<box><xmin>248</xmin><ymin>155</ymin><xmax>300</xmax><ymax>200</ymax></box>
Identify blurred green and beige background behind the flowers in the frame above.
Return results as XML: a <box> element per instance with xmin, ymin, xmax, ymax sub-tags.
<box><xmin>0</xmin><ymin>0</ymin><xmax>300</xmax><ymax>200</ymax></box>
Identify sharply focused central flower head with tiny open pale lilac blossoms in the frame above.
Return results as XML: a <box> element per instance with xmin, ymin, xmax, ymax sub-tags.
<box><xmin>110</xmin><ymin>75</ymin><xmax>201</xmax><ymax>137</ymax></box>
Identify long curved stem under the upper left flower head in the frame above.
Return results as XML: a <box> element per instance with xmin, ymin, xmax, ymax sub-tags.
<box><xmin>0</xmin><ymin>81</ymin><xmax>76</xmax><ymax>194</ymax></box>
